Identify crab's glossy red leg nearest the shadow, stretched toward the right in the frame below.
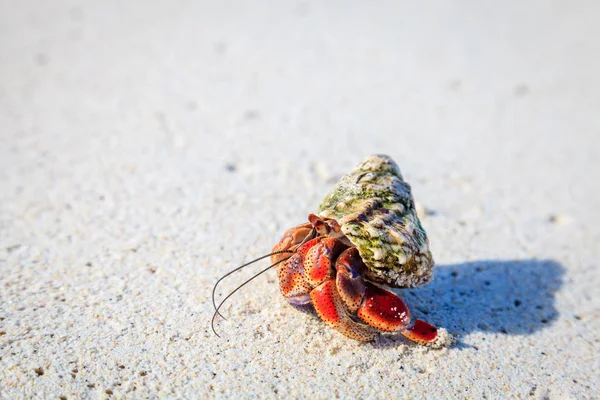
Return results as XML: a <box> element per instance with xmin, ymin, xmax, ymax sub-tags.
<box><xmin>336</xmin><ymin>247</ymin><xmax>437</xmax><ymax>343</ymax></box>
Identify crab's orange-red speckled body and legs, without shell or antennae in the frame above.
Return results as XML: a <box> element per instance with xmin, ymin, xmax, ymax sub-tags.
<box><xmin>271</xmin><ymin>214</ymin><xmax>437</xmax><ymax>343</ymax></box>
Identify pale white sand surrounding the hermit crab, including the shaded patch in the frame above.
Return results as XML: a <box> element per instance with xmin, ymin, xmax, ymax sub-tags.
<box><xmin>0</xmin><ymin>0</ymin><xmax>600</xmax><ymax>399</ymax></box>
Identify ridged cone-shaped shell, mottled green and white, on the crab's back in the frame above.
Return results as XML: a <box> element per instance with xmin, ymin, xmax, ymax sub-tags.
<box><xmin>319</xmin><ymin>155</ymin><xmax>434</xmax><ymax>288</ymax></box>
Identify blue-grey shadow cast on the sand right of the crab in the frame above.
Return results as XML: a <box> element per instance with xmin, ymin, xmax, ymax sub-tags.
<box><xmin>399</xmin><ymin>259</ymin><xmax>565</xmax><ymax>336</ymax></box>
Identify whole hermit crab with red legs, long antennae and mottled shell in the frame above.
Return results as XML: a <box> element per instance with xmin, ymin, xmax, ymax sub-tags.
<box><xmin>212</xmin><ymin>155</ymin><xmax>448</xmax><ymax>347</ymax></box>
